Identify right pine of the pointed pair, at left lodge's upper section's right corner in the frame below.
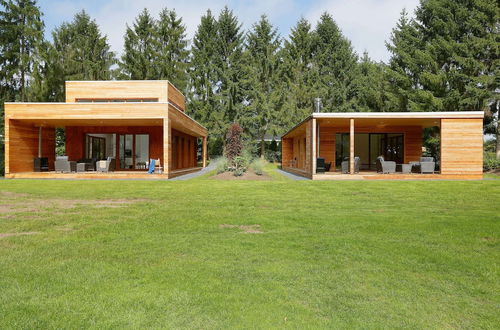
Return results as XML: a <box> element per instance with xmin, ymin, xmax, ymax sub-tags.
<box><xmin>155</xmin><ymin>8</ymin><xmax>189</xmax><ymax>91</ymax></box>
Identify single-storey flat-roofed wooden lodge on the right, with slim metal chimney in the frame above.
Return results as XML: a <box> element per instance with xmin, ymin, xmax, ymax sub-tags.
<box><xmin>282</xmin><ymin>111</ymin><xmax>484</xmax><ymax>180</ymax></box>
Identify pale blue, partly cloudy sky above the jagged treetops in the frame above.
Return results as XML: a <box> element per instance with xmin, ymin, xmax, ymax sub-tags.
<box><xmin>38</xmin><ymin>0</ymin><xmax>419</xmax><ymax>62</ymax></box>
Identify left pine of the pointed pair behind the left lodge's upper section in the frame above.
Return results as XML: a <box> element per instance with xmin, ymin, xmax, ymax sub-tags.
<box><xmin>120</xmin><ymin>8</ymin><xmax>159</xmax><ymax>80</ymax></box>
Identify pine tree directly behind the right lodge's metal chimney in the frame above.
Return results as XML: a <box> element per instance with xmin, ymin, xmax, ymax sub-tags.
<box><xmin>313</xmin><ymin>13</ymin><xmax>358</xmax><ymax>112</ymax></box>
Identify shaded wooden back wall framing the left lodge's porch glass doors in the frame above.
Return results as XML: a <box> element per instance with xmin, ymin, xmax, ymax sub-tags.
<box><xmin>65</xmin><ymin>126</ymin><xmax>163</xmax><ymax>164</ymax></box>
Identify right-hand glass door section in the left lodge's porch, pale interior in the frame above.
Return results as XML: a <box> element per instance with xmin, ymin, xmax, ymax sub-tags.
<box><xmin>118</xmin><ymin>134</ymin><xmax>149</xmax><ymax>170</ymax></box>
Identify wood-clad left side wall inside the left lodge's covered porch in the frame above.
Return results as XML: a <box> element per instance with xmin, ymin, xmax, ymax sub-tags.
<box><xmin>5</xmin><ymin>120</ymin><xmax>56</xmax><ymax>173</ymax></box>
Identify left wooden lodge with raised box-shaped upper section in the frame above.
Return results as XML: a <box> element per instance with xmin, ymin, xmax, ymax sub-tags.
<box><xmin>5</xmin><ymin>80</ymin><xmax>207</xmax><ymax>178</ymax></box>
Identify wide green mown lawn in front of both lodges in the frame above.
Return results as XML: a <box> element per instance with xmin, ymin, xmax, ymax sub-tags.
<box><xmin>0</xmin><ymin>169</ymin><xmax>500</xmax><ymax>329</ymax></box>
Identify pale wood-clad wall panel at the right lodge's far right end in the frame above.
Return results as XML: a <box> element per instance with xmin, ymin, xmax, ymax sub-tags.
<box><xmin>441</xmin><ymin>119</ymin><xmax>483</xmax><ymax>174</ymax></box>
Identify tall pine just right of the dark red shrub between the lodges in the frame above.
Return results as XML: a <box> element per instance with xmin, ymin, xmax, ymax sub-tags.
<box><xmin>243</xmin><ymin>16</ymin><xmax>284</xmax><ymax>157</ymax></box>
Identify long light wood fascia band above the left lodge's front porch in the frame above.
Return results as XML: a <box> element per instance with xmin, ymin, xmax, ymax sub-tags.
<box><xmin>5</xmin><ymin>103</ymin><xmax>168</xmax><ymax>123</ymax></box>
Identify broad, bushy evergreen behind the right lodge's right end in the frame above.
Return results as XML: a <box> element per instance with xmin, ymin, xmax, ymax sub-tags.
<box><xmin>388</xmin><ymin>0</ymin><xmax>500</xmax><ymax>111</ymax></box>
